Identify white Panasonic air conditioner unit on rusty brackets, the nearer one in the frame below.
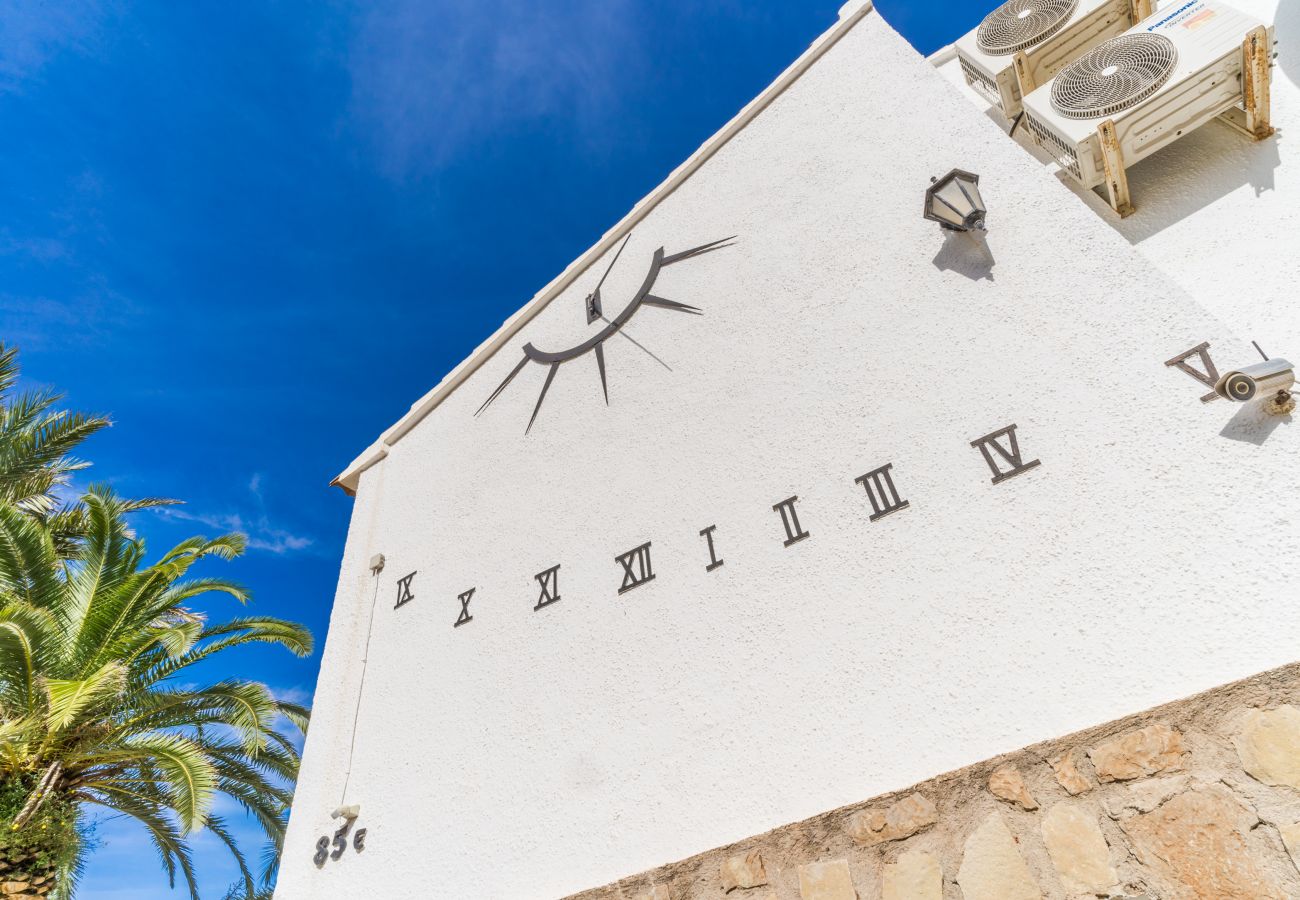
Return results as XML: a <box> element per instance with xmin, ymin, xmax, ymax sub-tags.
<box><xmin>1024</xmin><ymin>0</ymin><xmax>1273</xmax><ymax>216</ymax></box>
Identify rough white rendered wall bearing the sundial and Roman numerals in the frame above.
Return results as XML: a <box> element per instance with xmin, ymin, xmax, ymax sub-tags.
<box><xmin>277</xmin><ymin>7</ymin><xmax>1300</xmax><ymax>900</ymax></box>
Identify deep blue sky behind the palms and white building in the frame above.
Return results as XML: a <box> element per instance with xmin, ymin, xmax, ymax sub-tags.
<box><xmin>0</xmin><ymin>0</ymin><xmax>996</xmax><ymax>900</ymax></box>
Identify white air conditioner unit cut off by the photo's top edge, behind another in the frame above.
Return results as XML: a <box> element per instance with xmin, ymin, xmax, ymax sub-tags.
<box><xmin>956</xmin><ymin>0</ymin><xmax>1151</xmax><ymax>118</ymax></box>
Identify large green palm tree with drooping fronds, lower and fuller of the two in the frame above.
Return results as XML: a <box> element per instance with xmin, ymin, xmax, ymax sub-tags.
<box><xmin>0</xmin><ymin>488</ymin><xmax>312</xmax><ymax>897</ymax></box>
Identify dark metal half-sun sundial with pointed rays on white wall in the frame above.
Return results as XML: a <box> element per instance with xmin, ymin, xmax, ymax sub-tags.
<box><xmin>475</xmin><ymin>234</ymin><xmax>736</xmax><ymax>434</ymax></box>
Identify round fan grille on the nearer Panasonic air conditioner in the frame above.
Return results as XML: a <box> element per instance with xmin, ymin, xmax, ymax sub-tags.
<box><xmin>1052</xmin><ymin>33</ymin><xmax>1178</xmax><ymax>118</ymax></box>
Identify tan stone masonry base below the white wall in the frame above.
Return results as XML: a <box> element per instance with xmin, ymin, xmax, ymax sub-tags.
<box><xmin>572</xmin><ymin>663</ymin><xmax>1300</xmax><ymax>900</ymax></box>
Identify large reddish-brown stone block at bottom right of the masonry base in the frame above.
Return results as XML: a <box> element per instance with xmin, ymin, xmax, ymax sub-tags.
<box><xmin>1121</xmin><ymin>784</ymin><xmax>1286</xmax><ymax>900</ymax></box>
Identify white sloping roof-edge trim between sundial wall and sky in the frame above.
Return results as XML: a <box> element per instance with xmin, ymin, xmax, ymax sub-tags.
<box><xmin>330</xmin><ymin>0</ymin><xmax>872</xmax><ymax>494</ymax></box>
